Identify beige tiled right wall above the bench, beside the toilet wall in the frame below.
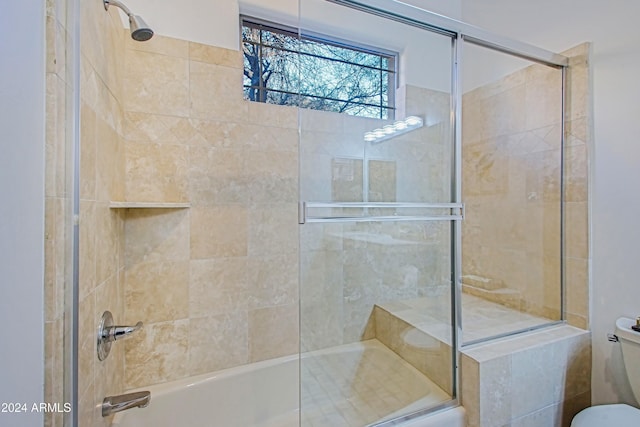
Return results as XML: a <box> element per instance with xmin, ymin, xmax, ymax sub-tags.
<box><xmin>462</xmin><ymin>45</ymin><xmax>589</xmax><ymax>328</ymax></box>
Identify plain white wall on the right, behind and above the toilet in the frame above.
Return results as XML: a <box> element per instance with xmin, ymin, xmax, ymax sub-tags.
<box><xmin>463</xmin><ymin>0</ymin><xmax>640</xmax><ymax>404</ymax></box>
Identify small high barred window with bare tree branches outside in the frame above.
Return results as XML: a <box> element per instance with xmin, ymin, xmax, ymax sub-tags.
<box><xmin>242</xmin><ymin>17</ymin><xmax>396</xmax><ymax>119</ymax></box>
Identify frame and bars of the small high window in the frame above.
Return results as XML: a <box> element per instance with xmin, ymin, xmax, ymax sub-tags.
<box><xmin>240</xmin><ymin>15</ymin><xmax>399</xmax><ymax>120</ymax></box>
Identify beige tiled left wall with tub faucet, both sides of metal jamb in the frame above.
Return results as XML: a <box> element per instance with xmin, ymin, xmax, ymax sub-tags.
<box><xmin>45</xmin><ymin>0</ymin><xmax>129</xmax><ymax>426</ymax></box>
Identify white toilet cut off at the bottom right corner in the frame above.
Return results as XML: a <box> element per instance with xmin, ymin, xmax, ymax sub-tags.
<box><xmin>571</xmin><ymin>317</ymin><xmax>640</xmax><ymax>427</ymax></box>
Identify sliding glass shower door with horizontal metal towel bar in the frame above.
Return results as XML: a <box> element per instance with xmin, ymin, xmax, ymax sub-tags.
<box><xmin>299</xmin><ymin>0</ymin><xmax>462</xmax><ymax>426</ymax></box>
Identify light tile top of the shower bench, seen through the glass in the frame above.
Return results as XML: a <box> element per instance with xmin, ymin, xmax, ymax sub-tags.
<box><xmin>378</xmin><ymin>293</ymin><xmax>551</xmax><ymax>343</ymax></box>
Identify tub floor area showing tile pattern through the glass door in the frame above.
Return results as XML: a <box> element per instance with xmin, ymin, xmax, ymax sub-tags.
<box><xmin>301</xmin><ymin>339</ymin><xmax>451</xmax><ymax>427</ymax></box>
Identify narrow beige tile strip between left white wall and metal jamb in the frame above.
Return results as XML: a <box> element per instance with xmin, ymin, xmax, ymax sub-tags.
<box><xmin>44</xmin><ymin>0</ymin><xmax>71</xmax><ymax>427</ymax></box>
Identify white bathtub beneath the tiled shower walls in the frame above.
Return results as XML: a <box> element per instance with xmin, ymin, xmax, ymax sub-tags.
<box><xmin>112</xmin><ymin>340</ymin><xmax>464</xmax><ymax>427</ymax></box>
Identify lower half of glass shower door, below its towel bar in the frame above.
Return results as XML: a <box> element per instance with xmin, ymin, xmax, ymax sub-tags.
<box><xmin>300</xmin><ymin>221</ymin><xmax>453</xmax><ymax>426</ymax></box>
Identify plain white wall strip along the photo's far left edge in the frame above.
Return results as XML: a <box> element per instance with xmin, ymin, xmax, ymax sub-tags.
<box><xmin>0</xmin><ymin>0</ymin><xmax>45</xmax><ymax>427</ymax></box>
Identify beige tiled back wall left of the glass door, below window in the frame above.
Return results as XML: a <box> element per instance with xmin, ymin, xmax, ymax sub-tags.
<box><xmin>123</xmin><ymin>36</ymin><xmax>298</xmax><ymax>388</ymax></box>
